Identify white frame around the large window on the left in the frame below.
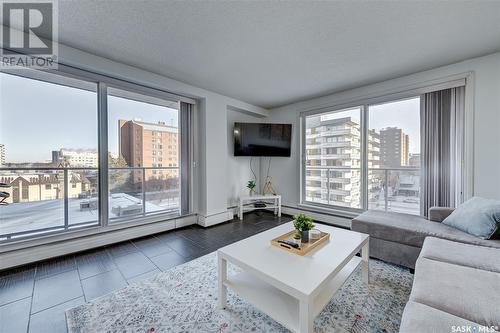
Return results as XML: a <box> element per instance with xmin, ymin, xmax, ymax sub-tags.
<box><xmin>0</xmin><ymin>64</ymin><xmax>197</xmax><ymax>241</ymax></box>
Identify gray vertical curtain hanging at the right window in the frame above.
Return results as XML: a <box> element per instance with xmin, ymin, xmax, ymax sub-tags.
<box><xmin>420</xmin><ymin>86</ymin><xmax>465</xmax><ymax>216</ymax></box>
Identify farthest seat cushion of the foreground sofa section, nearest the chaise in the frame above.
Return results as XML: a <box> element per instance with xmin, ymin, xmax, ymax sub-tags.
<box><xmin>420</xmin><ymin>237</ymin><xmax>500</xmax><ymax>273</ymax></box>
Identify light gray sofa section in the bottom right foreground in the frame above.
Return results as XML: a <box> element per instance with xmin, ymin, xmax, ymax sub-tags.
<box><xmin>400</xmin><ymin>237</ymin><xmax>500</xmax><ymax>333</ymax></box>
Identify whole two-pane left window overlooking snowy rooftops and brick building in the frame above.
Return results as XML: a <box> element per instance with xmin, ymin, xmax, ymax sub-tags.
<box><xmin>0</xmin><ymin>70</ymin><xmax>192</xmax><ymax>242</ymax></box>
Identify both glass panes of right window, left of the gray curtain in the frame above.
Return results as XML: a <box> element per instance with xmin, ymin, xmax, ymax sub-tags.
<box><xmin>302</xmin><ymin>97</ymin><xmax>420</xmax><ymax>214</ymax></box>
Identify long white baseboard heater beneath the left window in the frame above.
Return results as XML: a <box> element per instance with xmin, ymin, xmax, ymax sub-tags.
<box><xmin>0</xmin><ymin>215</ymin><xmax>196</xmax><ymax>270</ymax></box>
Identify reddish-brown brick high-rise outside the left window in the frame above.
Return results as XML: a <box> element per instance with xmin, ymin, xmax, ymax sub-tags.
<box><xmin>118</xmin><ymin>119</ymin><xmax>179</xmax><ymax>182</ymax></box>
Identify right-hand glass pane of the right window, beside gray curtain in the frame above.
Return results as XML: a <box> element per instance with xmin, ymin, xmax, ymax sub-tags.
<box><xmin>368</xmin><ymin>97</ymin><xmax>420</xmax><ymax>215</ymax></box>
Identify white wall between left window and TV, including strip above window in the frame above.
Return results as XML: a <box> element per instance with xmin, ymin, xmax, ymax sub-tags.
<box><xmin>54</xmin><ymin>45</ymin><xmax>268</xmax><ymax>224</ymax></box>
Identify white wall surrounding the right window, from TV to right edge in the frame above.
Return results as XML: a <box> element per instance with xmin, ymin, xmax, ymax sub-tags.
<box><xmin>269</xmin><ymin>53</ymin><xmax>500</xmax><ymax>207</ymax></box>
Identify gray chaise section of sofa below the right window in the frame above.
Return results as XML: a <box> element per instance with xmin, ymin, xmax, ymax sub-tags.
<box><xmin>351</xmin><ymin>207</ymin><xmax>500</xmax><ymax>269</ymax></box>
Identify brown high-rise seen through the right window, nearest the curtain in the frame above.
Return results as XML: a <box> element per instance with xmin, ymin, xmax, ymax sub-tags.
<box><xmin>380</xmin><ymin>127</ymin><xmax>410</xmax><ymax>167</ymax></box>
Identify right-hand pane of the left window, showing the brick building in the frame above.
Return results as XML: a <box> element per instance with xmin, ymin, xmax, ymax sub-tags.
<box><xmin>108</xmin><ymin>88</ymin><xmax>180</xmax><ymax>221</ymax></box>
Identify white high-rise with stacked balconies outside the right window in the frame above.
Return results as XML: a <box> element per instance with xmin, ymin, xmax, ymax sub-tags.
<box><xmin>306</xmin><ymin>116</ymin><xmax>380</xmax><ymax>208</ymax></box>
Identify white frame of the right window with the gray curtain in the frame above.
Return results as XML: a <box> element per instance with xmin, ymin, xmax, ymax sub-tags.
<box><xmin>298</xmin><ymin>72</ymin><xmax>473</xmax><ymax>218</ymax></box>
